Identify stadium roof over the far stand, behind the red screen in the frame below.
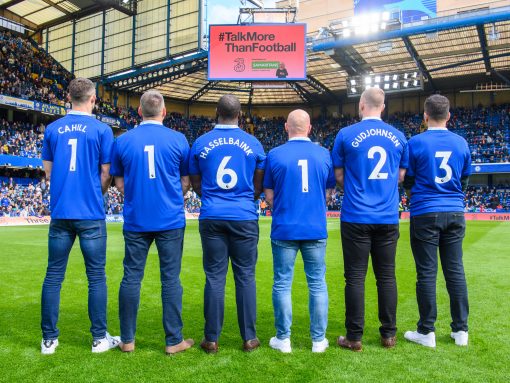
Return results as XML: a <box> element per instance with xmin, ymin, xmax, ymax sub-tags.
<box><xmin>104</xmin><ymin>7</ymin><xmax>510</xmax><ymax>104</ymax></box>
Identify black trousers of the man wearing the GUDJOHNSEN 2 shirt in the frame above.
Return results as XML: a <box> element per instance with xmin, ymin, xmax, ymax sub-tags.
<box><xmin>341</xmin><ymin>222</ymin><xmax>399</xmax><ymax>341</ymax></box>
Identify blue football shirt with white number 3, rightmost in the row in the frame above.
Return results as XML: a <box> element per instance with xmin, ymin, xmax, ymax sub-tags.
<box><xmin>407</xmin><ymin>128</ymin><xmax>471</xmax><ymax>216</ymax></box>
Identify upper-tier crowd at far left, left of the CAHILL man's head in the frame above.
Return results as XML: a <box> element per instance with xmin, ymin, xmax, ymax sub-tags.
<box><xmin>0</xmin><ymin>30</ymin><xmax>72</xmax><ymax>105</ymax></box>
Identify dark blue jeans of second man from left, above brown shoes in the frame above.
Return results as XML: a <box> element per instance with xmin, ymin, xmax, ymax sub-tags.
<box><xmin>119</xmin><ymin>228</ymin><xmax>184</xmax><ymax>346</ymax></box>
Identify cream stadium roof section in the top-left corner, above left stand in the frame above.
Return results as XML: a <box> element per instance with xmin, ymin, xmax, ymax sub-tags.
<box><xmin>0</xmin><ymin>0</ymin><xmax>137</xmax><ymax>32</ymax></box>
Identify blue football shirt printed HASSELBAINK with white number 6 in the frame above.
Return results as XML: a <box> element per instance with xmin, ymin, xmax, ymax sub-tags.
<box><xmin>189</xmin><ymin>124</ymin><xmax>266</xmax><ymax>221</ymax></box>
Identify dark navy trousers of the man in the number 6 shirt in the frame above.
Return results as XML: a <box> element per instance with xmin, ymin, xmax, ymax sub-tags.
<box><xmin>199</xmin><ymin>220</ymin><xmax>259</xmax><ymax>342</ymax></box>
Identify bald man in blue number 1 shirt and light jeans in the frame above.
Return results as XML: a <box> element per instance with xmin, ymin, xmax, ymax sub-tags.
<box><xmin>264</xmin><ymin>109</ymin><xmax>336</xmax><ymax>353</ymax></box>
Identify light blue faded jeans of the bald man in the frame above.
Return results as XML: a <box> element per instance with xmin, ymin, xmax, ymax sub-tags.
<box><xmin>271</xmin><ymin>239</ymin><xmax>328</xmax><ymax>342</ymax></box>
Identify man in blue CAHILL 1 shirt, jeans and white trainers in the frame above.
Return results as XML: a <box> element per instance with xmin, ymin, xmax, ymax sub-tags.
<box><xmin>41</xmin><ymin>78</ymin><xmax>120</xmax><ymax>354</ymax></box>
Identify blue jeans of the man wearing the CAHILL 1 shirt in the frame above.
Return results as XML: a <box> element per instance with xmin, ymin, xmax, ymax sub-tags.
<box><xmin>41</xmin><ymin>219</ymin><xmax>107</xmax><ymax>340</ymax></box>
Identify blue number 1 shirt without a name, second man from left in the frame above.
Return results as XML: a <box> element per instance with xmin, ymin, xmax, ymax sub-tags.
<box><xmin>110</xmin><ymin>121</ymin><xmax>189</xmax><ymax>232</ymax></box>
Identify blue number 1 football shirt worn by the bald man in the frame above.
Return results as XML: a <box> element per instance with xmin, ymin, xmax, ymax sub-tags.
<box><xmin>264</xmin><ymin>138</ymin><xmax>336</xmax><ymax>241</ymax></box>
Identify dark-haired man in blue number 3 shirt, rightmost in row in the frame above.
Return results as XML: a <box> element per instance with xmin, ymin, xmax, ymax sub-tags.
<box><xmin>404</xmin><ymin>94</ymin><xmax>471</xmax><ymax>347</ymax></box>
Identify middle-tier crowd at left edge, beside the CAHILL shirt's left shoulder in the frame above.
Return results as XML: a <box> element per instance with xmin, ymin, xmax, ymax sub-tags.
<box><xmin>0</xmin><ymin>119</ymin><xmax>45</xmax><ymax>158</ymax></box>
